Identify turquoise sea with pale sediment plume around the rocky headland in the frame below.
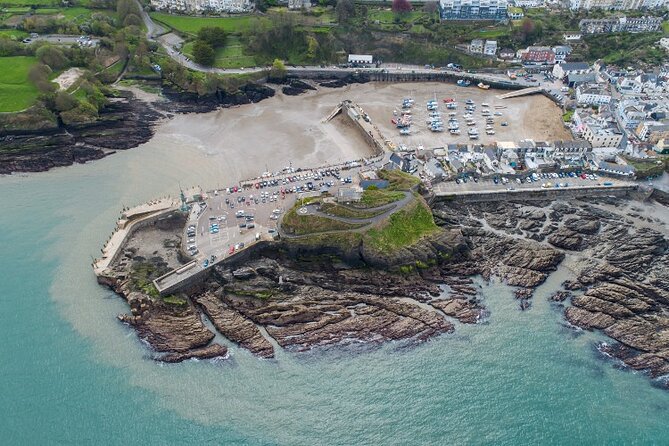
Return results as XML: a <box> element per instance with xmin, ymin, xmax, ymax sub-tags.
<box><xmin>0</xmin><ymin>146</ymin><xmax>669</xmax><ymax>445</ymax></box>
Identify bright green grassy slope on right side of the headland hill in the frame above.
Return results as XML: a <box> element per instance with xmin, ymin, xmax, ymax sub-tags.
<box><xmin>364</xmin><ymin>199</ymin><xmax>439</xmax><ymax>252</ymax></box>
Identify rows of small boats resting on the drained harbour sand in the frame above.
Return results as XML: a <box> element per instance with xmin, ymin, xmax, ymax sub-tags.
<box><xmin>392</xmin><ymin>98</ymin><xmax>508</xmax><ymax>140</ymax></box>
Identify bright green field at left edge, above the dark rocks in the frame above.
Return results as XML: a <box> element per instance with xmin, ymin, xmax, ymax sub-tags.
<box><xmin>0</xmin><ymin>56</ymin><xmax>39</xmax><ymax>112</ymax></box>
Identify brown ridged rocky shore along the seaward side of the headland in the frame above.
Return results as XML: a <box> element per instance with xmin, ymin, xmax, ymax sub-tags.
<box><xmin>100</xmin><ymin>193</ymin><xmax>669</xmax><ymax>385</ymax></box>
